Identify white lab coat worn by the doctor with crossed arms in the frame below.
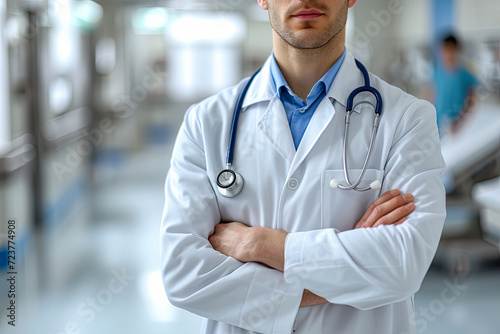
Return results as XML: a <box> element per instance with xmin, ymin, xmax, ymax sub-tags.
<box><xmin>161</xmin><ymin>53</ymin><xmax>445</xmax><ymax>334</ymax></box>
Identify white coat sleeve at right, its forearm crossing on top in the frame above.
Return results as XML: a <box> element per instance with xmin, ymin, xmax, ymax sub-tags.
<box><xmin>284</xmin><ymin>101</ymin><xmax>445</xmax><ymax>310</ymax></box>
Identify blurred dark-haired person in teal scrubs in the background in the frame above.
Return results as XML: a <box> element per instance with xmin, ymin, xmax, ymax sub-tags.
<box><xmin>426</xmin><ymin>34</ymin><xmax>477</xmax><ymax>136</ymax></box>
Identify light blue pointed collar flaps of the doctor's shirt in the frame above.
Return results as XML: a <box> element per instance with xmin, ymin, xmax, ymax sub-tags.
<box><xmin>270</xmin><ymin>48</ymin><xmax>346</xmax><ymax>99</ymax></box>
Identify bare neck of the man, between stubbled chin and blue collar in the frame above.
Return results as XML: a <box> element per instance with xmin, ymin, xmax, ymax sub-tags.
<box><xmin>273</xmin><ymin>30</ymin><xmax>345</xmax><ymax>101</ymax></box>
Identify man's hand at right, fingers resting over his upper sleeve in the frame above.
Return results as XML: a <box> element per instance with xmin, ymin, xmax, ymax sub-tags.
<box><xmin>354</xmin><ymin>189</ymin><xmax>415</xmax><ymax>229</ymax></box>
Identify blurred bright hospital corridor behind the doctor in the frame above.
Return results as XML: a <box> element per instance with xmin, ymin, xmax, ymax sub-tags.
<box><xmin>0</xmin><ymin>0</ymin><xmax>500</xmax><ymax>334</ymax></box>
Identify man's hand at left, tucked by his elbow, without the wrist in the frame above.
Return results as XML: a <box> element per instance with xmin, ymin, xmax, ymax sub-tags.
<box><xmin>208</xmin><ymin>222</ymin><xmax>255</xmax><ymax>262</ymax></box>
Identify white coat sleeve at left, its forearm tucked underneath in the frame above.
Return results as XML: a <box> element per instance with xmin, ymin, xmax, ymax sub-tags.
<box><xmin>160</xmin><ymin>108</ymin><xmax>303</xmax><ymax>333</ymax></box>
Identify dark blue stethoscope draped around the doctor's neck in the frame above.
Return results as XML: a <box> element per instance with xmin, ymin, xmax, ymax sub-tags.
<box><xmin>217</xmin><ymin>59</ymin><xmax>383</xmax><ymax>198</ymax></box>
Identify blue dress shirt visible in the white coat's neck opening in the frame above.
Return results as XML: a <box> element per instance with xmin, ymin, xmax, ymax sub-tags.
<box><xmin>271</xmin><ymin>49</ymin><xmax>346</xmax><ymax>149</ymax></box>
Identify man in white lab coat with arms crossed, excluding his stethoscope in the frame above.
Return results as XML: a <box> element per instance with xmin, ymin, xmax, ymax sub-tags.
<box><xmin>161</xmin><ymin>0</ymin><xmax>445</xmax><ymax>334</ymax></box>
